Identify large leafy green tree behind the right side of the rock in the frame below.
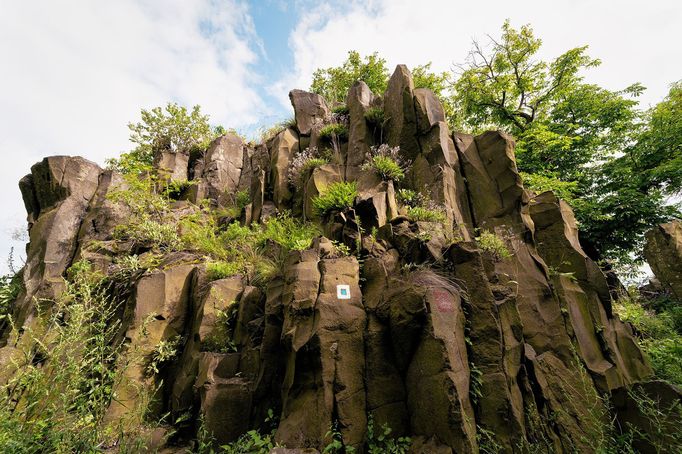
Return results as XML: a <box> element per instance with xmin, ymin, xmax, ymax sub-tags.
<box><xmin>453</xmin><ymin>21</ymin><xmax>681</xmax><ymax>262</ymax></box>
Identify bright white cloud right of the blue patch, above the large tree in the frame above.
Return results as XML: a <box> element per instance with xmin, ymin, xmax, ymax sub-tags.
<box><xmin>269</xmin><ymin>0</ymin><xmax>682</xmax><ymax>106</ymax></box>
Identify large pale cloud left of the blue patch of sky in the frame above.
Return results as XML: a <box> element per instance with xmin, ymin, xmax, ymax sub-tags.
<box><xmin>0</xmin><ymin>0</ymin><xmax>265</xmax><ymax>270</ymax></box>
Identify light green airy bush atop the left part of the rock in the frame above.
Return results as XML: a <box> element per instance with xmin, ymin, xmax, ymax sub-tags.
<box><xmin>107</xmin><ymin>103</ymin><xmax>220</xmax><ymax>173</ymax></box>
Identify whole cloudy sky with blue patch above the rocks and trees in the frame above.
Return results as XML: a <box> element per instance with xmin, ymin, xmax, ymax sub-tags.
<box><xmin>0</xmin><ymin>0</ymin><xmax>682</xmax><ymax>272</ymax></box>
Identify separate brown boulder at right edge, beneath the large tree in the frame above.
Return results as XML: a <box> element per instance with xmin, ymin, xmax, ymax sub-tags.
<box><xmin>644</xmin><ymin>221</ymin><xmax>682</xmax><ymax>300</ymax></box>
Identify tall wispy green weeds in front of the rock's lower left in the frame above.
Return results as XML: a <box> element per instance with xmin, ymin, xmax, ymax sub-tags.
<box><xmin>0</xmin><ymin>262</ymin><xmax>134</xmax><ymax>453</ymax></box>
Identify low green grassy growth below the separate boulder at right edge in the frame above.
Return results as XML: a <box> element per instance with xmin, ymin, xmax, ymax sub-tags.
<box><xmin>614</xmin><ymin>289</ymin><xmax>682</xmax><ymax>386</ymax></box>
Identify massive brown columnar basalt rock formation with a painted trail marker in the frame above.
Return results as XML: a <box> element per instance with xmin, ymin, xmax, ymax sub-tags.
<box><xmin>0</xmin><ymin>66</ymin><xmax>679</xmax><ymax>453</ymax></box>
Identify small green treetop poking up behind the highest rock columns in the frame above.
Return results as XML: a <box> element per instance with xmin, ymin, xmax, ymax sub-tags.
<box><xmin>310</xmin><ymin>50</ymin><xmax>389</xmax><ymax>103</ymax></box>
